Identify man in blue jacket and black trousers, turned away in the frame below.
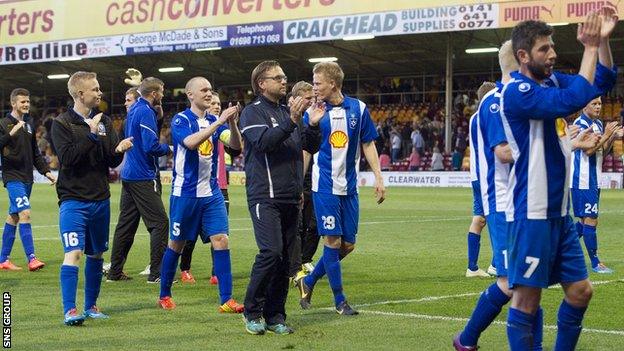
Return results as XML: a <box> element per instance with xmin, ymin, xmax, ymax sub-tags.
<box><xmin>107</xmin><ymin>77</ymin><xmax>170</xmax><ymax>283</ymax></box>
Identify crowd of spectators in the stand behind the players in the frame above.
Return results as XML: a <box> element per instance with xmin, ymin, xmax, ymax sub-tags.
<box><xmin>5</xmin><ymin>78</ymin><xmax>624</xmax><ymax>175</ymax></box>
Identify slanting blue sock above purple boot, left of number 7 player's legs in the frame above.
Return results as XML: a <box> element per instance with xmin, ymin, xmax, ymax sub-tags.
<box><xmin>459</xmin><ymin>283</ymin><xmax>509</xmax><ymax>346</ymax></box>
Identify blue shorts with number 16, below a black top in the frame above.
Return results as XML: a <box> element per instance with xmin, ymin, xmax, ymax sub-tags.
<box><xmin>59</xmin><ymin>199</ymin><xmax>110</xmax><ymax>255</ymax></box>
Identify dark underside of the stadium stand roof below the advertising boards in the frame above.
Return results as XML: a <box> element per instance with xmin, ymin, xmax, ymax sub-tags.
<box><xmin>0</xmin><ymin>24</ymin><xmax>624</xmax><ymax>101</ymax></box>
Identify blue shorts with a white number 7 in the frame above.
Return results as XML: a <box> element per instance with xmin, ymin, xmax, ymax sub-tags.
<box><xmin>508</xmin><ymin>216</ymin><xmax>588</xmax><ymax>288</ymax></box>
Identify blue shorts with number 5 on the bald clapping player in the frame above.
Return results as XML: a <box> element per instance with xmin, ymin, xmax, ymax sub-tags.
<box><xmin>169</xmin><ymin>192</ymin><xmax>229</xmax><ymax>243</ymax></box>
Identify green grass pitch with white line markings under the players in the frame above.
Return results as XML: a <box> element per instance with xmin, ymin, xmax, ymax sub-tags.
<box><xmin>0</xmin><ymin>184</ymin><xmax>624</xmax><ymax>351</ymax></box>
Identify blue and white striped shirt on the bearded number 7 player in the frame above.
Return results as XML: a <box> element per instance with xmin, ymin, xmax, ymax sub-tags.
<box><xmin>501</xmin><ymin>65</ymin><xmax>617</xmax><ymax>221</ymax></box>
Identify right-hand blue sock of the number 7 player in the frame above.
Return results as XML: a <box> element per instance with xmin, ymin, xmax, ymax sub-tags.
<box><xmin>554</xmin><ymin>300</ymin><xmax>587</xmax><ymax>351</ymax></box>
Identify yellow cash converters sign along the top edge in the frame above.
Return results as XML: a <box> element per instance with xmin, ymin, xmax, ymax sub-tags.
<box><xmin>0</xmin><ymin>0</ymin><xmax>504</xmax><ymax>45</ymax></box>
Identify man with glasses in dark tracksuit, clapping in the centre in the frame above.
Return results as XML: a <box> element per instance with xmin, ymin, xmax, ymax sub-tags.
<box><xmin>241</xmin><ymin>61</ymin><xmax>314</xmax><ymax>335</ymax></box>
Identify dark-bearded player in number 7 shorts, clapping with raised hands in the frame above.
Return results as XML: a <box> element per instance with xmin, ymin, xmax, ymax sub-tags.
<box><xmin>500</xmin><ymin>7</ymin><xmax>618</xmax><ymax>351</ymax></box>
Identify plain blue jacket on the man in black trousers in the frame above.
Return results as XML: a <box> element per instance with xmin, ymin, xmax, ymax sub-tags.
<box><xmin>121</xmin><ymin>98</ymin><xmax>169</xmax><ymax>181</ymax></box>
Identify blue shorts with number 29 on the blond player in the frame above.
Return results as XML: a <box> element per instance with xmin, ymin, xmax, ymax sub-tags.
<box><xmin>312</xmin><ymin>192</ymin><xmax>360</xmax><ymax>244</ymax></box>
